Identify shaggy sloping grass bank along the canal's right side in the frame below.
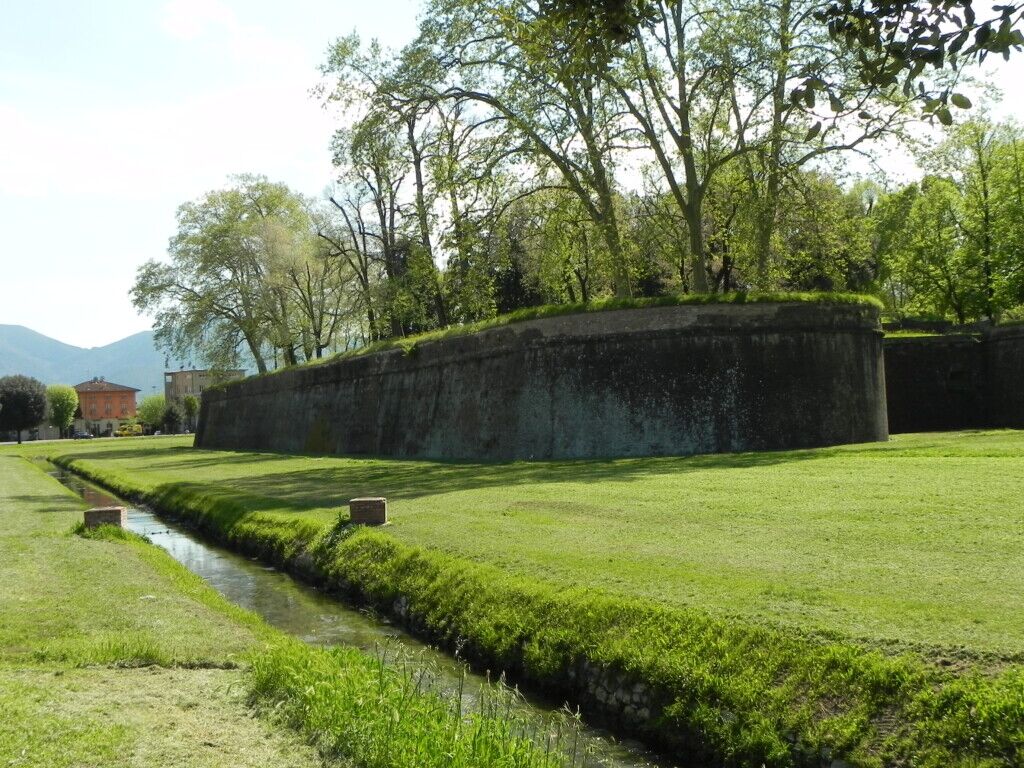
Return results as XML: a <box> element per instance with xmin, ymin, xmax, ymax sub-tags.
<box><xmin>34</xmin><ymin>448</ymin><xmax>1024</xmax><ymax>766</ymax></box>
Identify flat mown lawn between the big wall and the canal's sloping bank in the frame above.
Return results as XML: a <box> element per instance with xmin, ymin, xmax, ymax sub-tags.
<box><xmin>9</xmin><ymin>431</ymin><xmax>1024</xmax><ymax>662</ymax></box>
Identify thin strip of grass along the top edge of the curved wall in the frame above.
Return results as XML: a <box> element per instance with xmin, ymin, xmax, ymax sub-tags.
<box><xmin>208</xmin><ymin>292</ymin><xmax>883</xmax><ymax>390</ymax></box>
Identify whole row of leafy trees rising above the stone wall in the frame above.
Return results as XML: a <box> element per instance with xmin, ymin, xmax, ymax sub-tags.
<box><xmin>132</xmin><ymin>0</ymin><xmax>1024</xmax><ymax>372</ymax></box>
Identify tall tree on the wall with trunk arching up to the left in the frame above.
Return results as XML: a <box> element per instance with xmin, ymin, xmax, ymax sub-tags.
<box><xmin>421</xmin><ymin>0</ymin><xmax>632</xmax><ymax>296</ymax></box>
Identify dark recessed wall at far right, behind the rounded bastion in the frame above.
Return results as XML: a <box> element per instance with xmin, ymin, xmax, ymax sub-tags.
<box><xmin>885</xmin><ymin>325</ymin><xmax>1024</xmax><ymax>433</ymax></box>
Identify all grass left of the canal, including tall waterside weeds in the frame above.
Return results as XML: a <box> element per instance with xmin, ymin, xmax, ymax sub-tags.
<box><xmin>0</xmin><ymin>455</ymin><xmax>585</xmax><ymax>768</ymax></box>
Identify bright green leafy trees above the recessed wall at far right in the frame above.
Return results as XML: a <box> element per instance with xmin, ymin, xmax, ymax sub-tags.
<box><xmin>878</xmin><ymin>118</ymin><xmax>1024</xmax><ymax>324</ymax></box>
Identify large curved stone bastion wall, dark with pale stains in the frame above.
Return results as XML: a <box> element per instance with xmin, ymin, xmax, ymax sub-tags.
<box><xmin>196</xmin><ymin>302</ymin><xmax>888</xmax><ymax>460</ymax></box>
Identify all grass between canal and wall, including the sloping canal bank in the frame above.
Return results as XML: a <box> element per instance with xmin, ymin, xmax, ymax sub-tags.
<box><xmin>8</xmin><ymin>432</ymin><xmax>1024</xmax><ymax>766</ymax></box>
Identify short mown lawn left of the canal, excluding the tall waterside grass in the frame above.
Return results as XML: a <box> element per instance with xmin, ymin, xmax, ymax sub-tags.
<box><xmin>0</xmin><ymin>456</ymin><xmax>318</xmax><ymax>768</ymax></box>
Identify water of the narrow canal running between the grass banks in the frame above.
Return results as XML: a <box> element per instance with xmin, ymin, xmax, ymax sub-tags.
<box><xmin>50</xmin><ymin>466</ymin><xmax>672</xmax><ymax>768</ymax></box>
